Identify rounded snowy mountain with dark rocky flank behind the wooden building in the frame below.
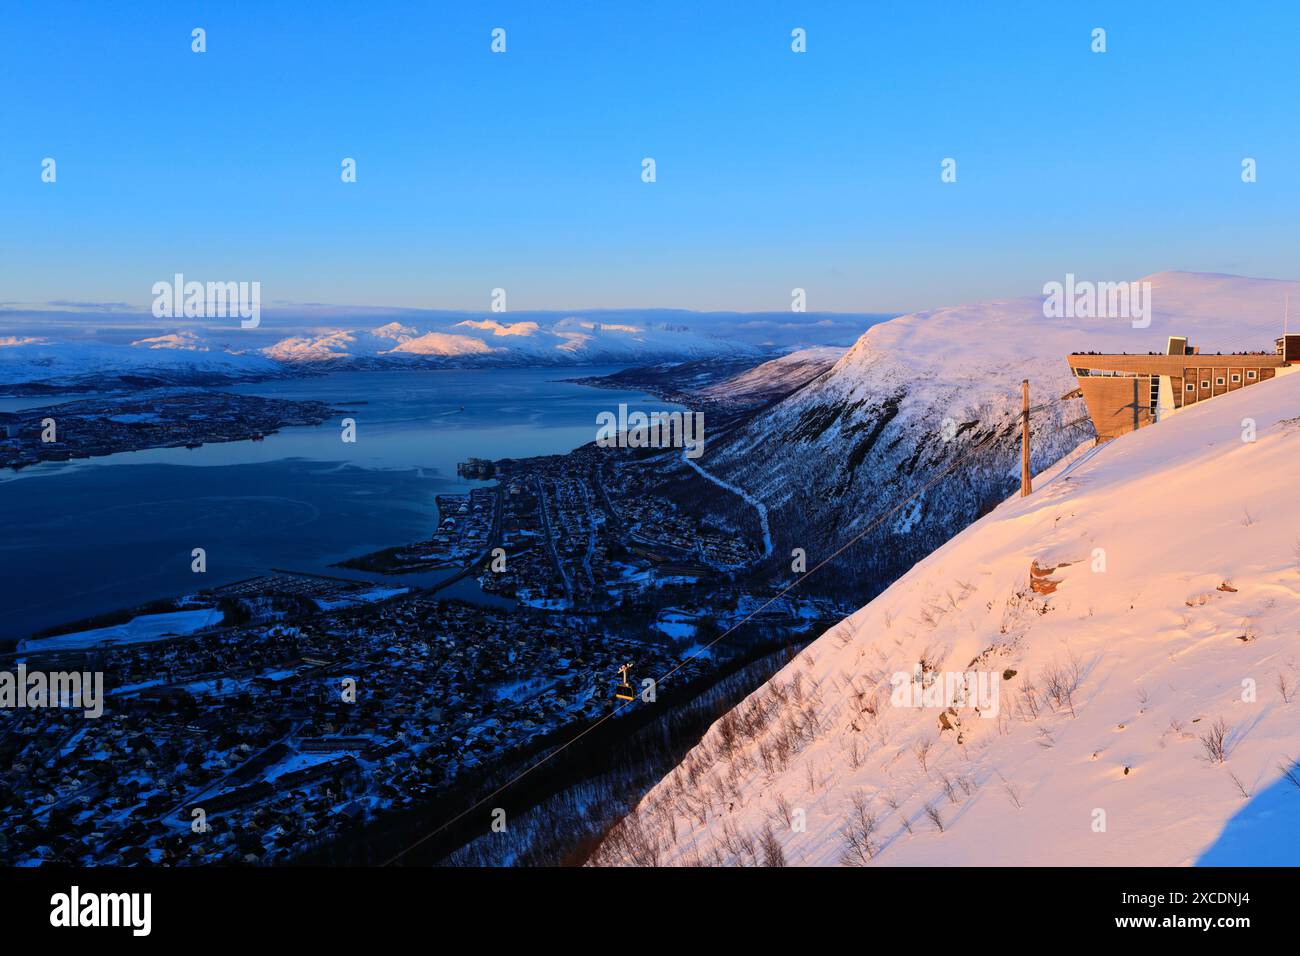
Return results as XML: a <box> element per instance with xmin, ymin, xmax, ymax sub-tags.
<box><xmin>699</xmin><ymin>272</ymin><xmax>1300</xmax><ymax>597</ymax></box>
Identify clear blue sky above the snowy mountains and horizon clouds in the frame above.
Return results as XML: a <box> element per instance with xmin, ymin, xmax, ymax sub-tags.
<box><xmin>0</xmin><ymin>0</ymin><xmax>1300</xmax><ymax>312</ymax></box>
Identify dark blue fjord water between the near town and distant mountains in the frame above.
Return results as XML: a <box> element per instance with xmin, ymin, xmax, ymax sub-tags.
<box><xmin>0</xmin><ymin>367</ymin><xmax>677</xmax><ymax>640</ymax></box>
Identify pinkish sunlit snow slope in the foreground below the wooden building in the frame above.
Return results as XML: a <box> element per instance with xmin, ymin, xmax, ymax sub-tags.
<box><xmin>595</xmin><ymin>371</ymin><xmax>1300</xmax><ymax>866</ymax></box>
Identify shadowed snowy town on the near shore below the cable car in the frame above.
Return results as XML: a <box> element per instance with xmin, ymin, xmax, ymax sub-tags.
<box><xmin>0</xmin><ymin>434</ymin><xmax>842</xmax><ymax>865</ymax></box>
